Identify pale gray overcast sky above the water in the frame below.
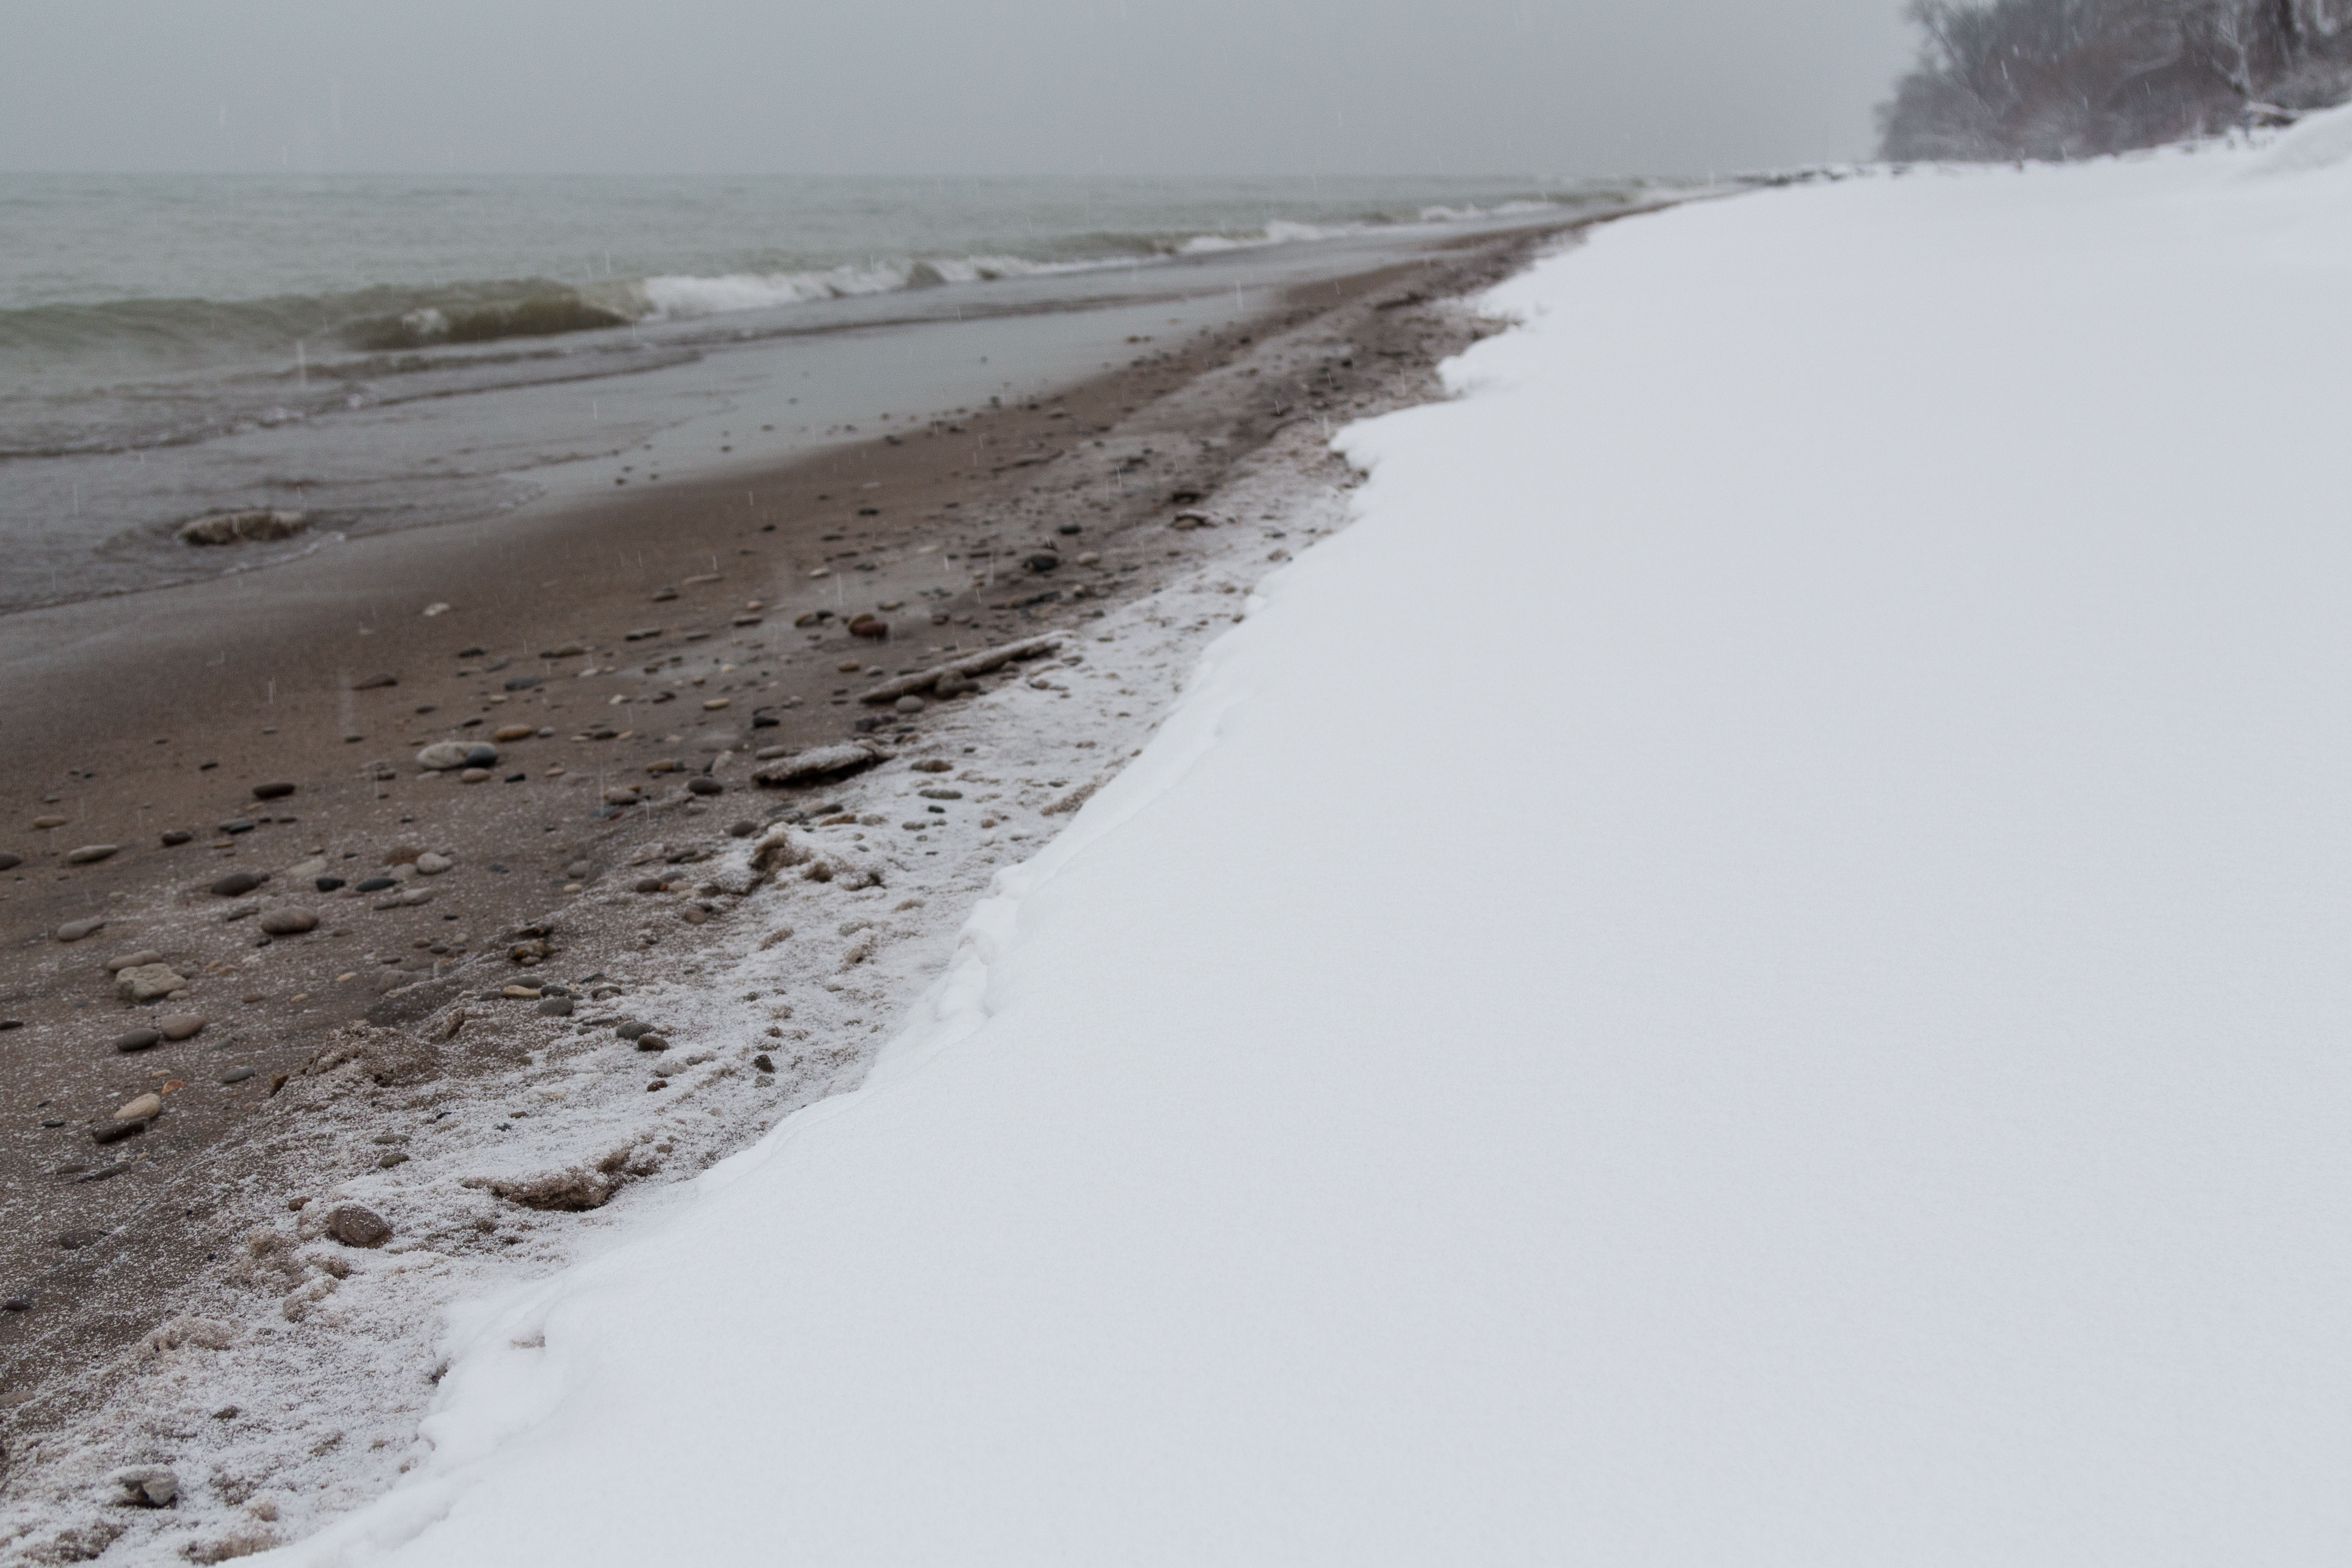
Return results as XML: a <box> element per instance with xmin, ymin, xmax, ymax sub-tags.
<box><xmin>0</xmin><ymin>0</ymin><xmax>1912</xmax><ymax>174</ymax></box>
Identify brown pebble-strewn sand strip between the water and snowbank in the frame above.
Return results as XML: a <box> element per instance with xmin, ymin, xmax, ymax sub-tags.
<box><xmin>0</xmin><ymin>219</ymin><xmax>1599</xmax><ymax>1561</ymax></box>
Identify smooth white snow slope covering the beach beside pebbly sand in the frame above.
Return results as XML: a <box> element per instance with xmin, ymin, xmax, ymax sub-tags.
<box><xmin>282</xmin><ymin>127</ymin><xmax>2352</xmax><ymax>1568</ymax></box>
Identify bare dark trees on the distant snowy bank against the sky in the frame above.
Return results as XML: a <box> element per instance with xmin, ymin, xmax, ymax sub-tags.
<box><xmin>1879</xmin><ymin>0</ymin><xmax>2352</xmax><ymax>162</ymax></box>
